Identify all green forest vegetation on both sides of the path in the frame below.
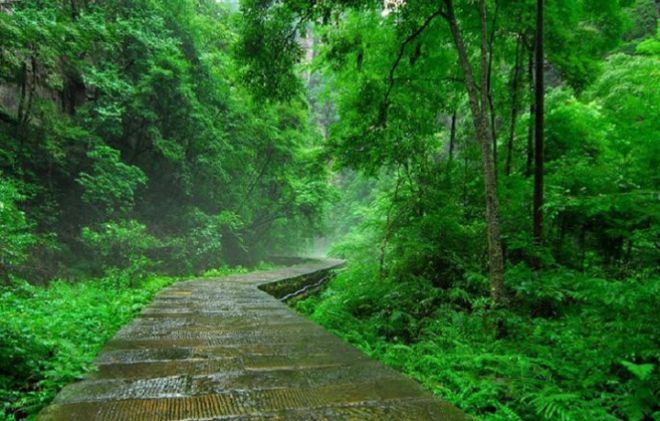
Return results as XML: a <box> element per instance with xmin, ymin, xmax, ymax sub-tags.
<box><xmin>0</xmin><ymin>0</ymin><xmax>660</xmax><ymax>420</ymax></box>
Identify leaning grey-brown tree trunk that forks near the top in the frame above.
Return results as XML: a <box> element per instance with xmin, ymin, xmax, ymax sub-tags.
<box><xmin>444</xmin><ymin>0</ymin><xmax>506</xmax><ymax>305</ymax></box>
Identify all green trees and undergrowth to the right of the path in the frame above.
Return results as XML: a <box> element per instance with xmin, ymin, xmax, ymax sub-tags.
<box><xmin>242</xmin><ymin>0</ymin><xmax>660</xmax><ymax>420</ymax></box>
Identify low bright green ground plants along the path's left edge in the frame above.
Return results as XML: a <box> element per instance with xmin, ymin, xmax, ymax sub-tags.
<box><xmin>0</xmin><ymin>264</ymin><xmax>273</xmax><ymax>420</ymax></box>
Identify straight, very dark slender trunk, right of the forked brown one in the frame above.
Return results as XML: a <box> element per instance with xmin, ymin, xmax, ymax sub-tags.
<box><xmin>533</xmin><ymin>0</ymin><xmax>545</xmax><ymax>245</ymax></box>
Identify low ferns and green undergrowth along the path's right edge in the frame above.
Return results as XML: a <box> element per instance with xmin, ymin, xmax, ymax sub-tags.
<box><xmin>296</xmin><ymin>265</ymin><xmax>660</xmax><ymax>420</ymax></box>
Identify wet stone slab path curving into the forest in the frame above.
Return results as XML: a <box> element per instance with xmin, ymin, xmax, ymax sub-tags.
<box><xmin>37</xmin><ymin>260</ymin><xmax>467</xmax><ymax>421</ymax></box>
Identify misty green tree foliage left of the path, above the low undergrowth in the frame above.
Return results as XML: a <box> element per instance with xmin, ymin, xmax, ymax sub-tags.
<box><xmin>0</xmin><ymin>0</ymin><xmax>331</xmax><ymax>280</ymax></box>
